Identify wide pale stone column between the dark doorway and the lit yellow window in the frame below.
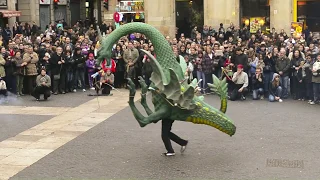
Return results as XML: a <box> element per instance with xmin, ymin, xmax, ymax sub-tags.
<box><xmin>203</xmin><ymin>0</ymin><xmax>240</xmax><ymax>29</ymax></box>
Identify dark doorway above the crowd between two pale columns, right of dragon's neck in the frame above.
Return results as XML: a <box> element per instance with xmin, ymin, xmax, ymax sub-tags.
<box><xmin>176</xmin><ymin>0</ymin><xmax>204</xmax><ymax>37</ymax></box>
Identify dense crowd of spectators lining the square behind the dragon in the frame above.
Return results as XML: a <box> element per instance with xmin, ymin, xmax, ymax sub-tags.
<box><xmin>0</xmin><ymin>22</ymin><xmax>320</xmax><ymax>104</ymax></box>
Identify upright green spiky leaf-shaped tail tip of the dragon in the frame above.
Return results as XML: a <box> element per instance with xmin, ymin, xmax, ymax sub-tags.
<box><xmin>208</xmin><ymin>74</ymin><xmax>228</xmax><ymax>113</ymax></box>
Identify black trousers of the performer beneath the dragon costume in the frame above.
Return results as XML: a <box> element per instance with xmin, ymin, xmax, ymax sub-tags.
<box><xmin>161</xmin><ymin>119</ymin><xmax>188</xmax><ymax>153</ymax></box>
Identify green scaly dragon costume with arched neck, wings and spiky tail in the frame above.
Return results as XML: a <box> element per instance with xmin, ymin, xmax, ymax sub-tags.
<box><xmin>98</xmin><ymin>23</ymin><xmax>236</xmax><ymax>136</ymax></box>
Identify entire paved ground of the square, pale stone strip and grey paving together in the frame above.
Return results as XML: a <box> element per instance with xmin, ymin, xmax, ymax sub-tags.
<box><xmin>0</xmin><ymin>90</ymin><xmax>320</xmax><ymax>180</ymax></box>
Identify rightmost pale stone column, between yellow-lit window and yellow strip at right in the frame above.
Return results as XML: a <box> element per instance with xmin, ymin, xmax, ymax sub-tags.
<box><xmin>270</xmin><ymin>0</ymin><xmax>293</xmax><ymax>34</ymax></box>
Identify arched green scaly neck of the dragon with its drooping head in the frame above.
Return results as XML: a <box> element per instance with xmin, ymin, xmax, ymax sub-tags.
<box><xmin>98</xmin><ymin>22</ymin><xmax>184</xmax><ymax>80</ymax></box>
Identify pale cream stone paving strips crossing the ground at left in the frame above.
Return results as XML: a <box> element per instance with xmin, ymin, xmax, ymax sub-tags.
<box><xmin>0</xmin><ymin>90</ymin><xmax>139</xmax><ymax>180</ymax></box>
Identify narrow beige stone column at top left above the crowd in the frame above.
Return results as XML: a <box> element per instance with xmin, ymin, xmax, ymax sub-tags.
<box><xmin>18</xmin><ymin>0</ymin><xmax>40</xmax><ymax>24</ymax></box>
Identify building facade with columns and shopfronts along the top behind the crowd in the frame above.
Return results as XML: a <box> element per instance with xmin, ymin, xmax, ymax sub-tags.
<box><xmin>0</xmin><ymin>0</ymin><xmax>320</xmax><ymax>37</ymax></box>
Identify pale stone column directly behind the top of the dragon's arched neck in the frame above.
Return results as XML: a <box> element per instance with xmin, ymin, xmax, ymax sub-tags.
<box><xmin>144</xmin><ymin>0</ymin><xmax>176</xmax><ymax>38</ymax></box>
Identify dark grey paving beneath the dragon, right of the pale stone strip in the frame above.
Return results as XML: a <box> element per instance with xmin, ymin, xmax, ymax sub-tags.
<box><xmin>6</xmin><ymin>96</ymin><xmax>320</xmax><ymax>180</ymax></box>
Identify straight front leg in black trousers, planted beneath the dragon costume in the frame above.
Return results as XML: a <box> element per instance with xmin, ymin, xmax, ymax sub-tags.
<box><xmin>161</xmin><ymin>119</ymin><xmax>174</xmax><ymax>153</ymax></box>
